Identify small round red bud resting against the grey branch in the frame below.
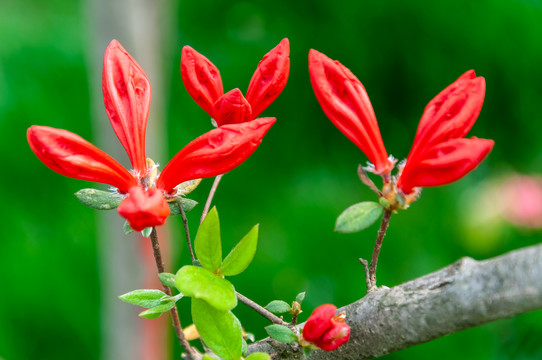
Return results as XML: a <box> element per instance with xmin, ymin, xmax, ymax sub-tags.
<box><xmin>303</xmin><ymin>304</ymin><xmax>350</xmax><ymax>351</ymax></box>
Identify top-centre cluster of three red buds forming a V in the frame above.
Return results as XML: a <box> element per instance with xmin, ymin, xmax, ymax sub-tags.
<box><xmin>181</xmin><ymin>39</ymin><xmax>290</xmax><ymax>126</ymax></box>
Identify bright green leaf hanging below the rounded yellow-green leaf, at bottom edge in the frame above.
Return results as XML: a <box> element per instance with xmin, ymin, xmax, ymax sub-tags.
<box><xmin>192</xmin><ymin>298</ymin><xmax>243</xmax><ymax>360</ymax></box>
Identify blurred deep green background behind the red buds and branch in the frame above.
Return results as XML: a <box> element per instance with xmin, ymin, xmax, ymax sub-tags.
<box><xmin>0</xmin><ymin>0</ymin><xmax>542</xmax><ymax>360</ymax></box>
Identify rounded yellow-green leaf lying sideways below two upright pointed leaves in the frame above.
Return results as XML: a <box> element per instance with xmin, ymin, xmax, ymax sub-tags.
<box><xmin>175</xmin><ymin>265</ymin><xmax>237</xmax><ymax>311</ymax></box>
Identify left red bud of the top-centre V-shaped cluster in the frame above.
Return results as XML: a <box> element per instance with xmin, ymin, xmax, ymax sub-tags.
<box><xmin>181</xmin><ymin>46</ymin><xmax>224</xmax><ymax>117</ymax></box>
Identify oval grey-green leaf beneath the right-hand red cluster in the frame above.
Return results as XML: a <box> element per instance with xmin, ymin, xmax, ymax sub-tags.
<box><xmin>335</xmin><ymin>201</ymin><xmax>384</xmax><ymax>233</ymax></box>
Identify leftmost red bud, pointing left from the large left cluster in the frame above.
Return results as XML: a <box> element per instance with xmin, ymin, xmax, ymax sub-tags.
<box><xmin>26</xmin><ymin>125</ymin><xmax>137</xmax><ymax>193</ymax></box>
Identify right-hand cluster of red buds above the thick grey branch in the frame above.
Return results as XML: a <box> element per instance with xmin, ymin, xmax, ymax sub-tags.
<box><xmin>309</xmin><ymin>49</ymin><xmax>494</xmax><ymax>195</ymax></box>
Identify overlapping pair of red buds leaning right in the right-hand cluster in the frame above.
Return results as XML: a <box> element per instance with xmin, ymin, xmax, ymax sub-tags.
<box><xmin>397</xmin><ymin>70</ymin><xmax>494</xmax><ymax>194</ymax></box>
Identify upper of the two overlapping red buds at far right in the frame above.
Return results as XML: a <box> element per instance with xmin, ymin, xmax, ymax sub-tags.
<box><xmin>411</xmin><ymin>70</ymin><xmax>486</xmax><ymax>152</ymax></box>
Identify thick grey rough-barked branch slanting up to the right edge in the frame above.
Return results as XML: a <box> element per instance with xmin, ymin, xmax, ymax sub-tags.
<box><xmin>249</xmin><ymin>245</ymin><xmax>542</xmax><ymax>360</ymax></box>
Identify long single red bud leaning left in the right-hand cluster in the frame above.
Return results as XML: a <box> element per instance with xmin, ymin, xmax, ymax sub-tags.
<box><xmin>309</xmin><ymin>49</ymin><xmax>393</xmax><ymax>174</ymax></box>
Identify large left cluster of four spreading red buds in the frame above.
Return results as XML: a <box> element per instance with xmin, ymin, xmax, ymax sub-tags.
<box><xmin>27</xmin><ymin>40</ymin><xmax>275</xmax><ymax>231</ymax></box>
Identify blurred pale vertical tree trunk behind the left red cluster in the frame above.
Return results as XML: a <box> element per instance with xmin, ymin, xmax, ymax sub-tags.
<box><xmin>85</xmin><ymin>0</ymin><xmax>175</xmax><ymax>360</ymax></box>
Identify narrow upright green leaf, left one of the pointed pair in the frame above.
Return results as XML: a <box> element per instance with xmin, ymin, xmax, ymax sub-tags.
<box><xmin>194</xmin><ymin>207</ymin><xmax>222</xmax><ymax>272</ymax></box>
